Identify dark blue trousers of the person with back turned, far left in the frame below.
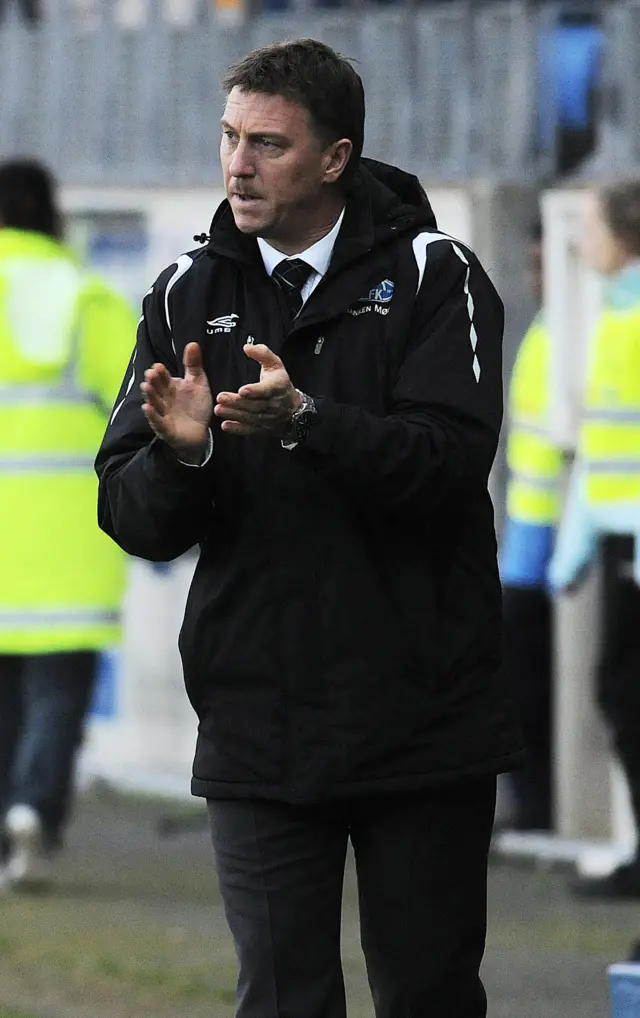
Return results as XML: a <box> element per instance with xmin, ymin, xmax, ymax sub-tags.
<box><xmin>0</xmin><ymin>652</ymin><xmax>97</xmax><ymax>845</ymax></box>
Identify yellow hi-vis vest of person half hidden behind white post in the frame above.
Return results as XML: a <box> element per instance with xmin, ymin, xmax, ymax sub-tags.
<box><xmin>507</xmin><ymin>316</ymin><xmax>563</xmax><ymax>525</ymax></box>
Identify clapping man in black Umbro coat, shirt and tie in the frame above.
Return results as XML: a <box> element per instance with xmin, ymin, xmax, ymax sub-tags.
<box><xmin>97</xmin><ymin>40</ymin><xmax>520</xmax><ymax>1018</ymax></box>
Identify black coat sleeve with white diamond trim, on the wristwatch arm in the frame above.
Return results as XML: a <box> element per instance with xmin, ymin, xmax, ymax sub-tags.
<box><xmin>294</xmin><ymin>240</ymin><xmax>504</xmax><ymax>517</ymax></box>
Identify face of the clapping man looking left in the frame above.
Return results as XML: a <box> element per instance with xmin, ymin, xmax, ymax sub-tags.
<box><xmin>220</xmin><ymin>89</ymin><xmax>352</xmax><ymax>253</ymax></box>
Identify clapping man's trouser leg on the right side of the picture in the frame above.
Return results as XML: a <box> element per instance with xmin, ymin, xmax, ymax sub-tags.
<box><xmin>351</xmin><ymin>777</ymin><xmax>496</xmax><ymax>1018</ymax></box>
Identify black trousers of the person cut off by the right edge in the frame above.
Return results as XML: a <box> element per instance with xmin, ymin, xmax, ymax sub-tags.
<box><xmin>597</xmin><ymin>536</ymin><xmax>640</xmax><ymax>833</ymax></box>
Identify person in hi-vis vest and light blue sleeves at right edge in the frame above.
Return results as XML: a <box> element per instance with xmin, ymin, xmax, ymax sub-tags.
<box><xmin>549</xmin><ymin>182</ymin><xmax>640</xmax><ymax>899</ymax></box>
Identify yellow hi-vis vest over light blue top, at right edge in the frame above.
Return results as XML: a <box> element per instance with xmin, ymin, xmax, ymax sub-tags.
<box><xmin>578</xmin><ymin>264</ymin><xmax>640</xmax><ymax>504</ymax></box>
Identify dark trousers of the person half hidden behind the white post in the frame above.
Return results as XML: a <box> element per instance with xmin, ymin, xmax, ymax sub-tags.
<box><xmin>503</xmin><ymin>586</ymin><xmax>554</xmax><ymax>830</ymax></box>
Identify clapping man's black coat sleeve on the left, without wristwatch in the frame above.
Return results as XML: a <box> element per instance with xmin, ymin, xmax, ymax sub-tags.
<box><xmin>96</xmin><ymin>276</ymin><xmax>213</xmax><ymax>562</ymax></box>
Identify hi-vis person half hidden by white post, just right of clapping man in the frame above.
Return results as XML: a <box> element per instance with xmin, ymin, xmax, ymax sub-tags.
<box><xmin>500</xmin><ymin>222</ymin><xmax>563</xmax><ymax>831</ymax></box>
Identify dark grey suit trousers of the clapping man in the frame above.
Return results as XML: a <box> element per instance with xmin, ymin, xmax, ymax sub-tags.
<box><xmin>209</xmin><ymin>777</ymin><xmax>496</xmax><ymax>1018</ymax></box>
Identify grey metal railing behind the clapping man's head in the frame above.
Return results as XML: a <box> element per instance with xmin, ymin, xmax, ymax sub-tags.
<box><xmin>0</xmin><ymin>0</ymin><xmax>640</xmax><ymax>186</ymax></box>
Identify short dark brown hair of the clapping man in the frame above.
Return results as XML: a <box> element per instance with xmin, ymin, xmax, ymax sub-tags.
<box><xmin>223</xmin><ymin>39</ymin><xmax>364</xmax><ymax>189</ymax></box>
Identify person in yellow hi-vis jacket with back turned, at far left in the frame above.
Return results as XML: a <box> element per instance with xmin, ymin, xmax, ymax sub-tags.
<box><xmin>0</xmin><ymin>161</ymin><xmax>135</xmax><ymax>886</ymax></box>
